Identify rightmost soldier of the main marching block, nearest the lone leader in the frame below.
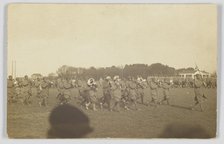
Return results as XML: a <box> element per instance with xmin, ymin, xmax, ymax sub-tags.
<box><xmin>160</xmin><ymin>78</ymin><xmax>170</xmax><ymax>105</ymax></box>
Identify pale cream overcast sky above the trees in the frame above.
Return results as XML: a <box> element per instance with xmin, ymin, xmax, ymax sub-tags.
<box><xmin>7</xmin><ymin>4</ymin><xmax>217</xmax><ymax>76</ymax></box>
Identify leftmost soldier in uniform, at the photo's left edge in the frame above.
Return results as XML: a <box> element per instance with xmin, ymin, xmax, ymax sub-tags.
<box><xmin>7</xmin><ymin>75</ymin><xmax>15</xmax><ymax>103</ymax></box>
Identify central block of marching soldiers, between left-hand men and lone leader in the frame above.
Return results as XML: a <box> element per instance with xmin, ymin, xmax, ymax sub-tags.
<box><xmin>53</xmin><ymin>76</ymin><xmax>170</xmax><ymax>111</ymax></box>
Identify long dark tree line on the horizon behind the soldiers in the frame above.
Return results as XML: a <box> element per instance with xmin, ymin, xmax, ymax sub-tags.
<box><xmin>56</xmin><ymin>63</ymin><xmax>185</xmax><ymax>79</ymax></box>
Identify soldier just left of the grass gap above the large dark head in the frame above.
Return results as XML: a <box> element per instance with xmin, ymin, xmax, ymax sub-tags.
<box><xmin>39</xmin><ymin>77</ymin><xmax>50</xmax><ymax>107</ymax></box>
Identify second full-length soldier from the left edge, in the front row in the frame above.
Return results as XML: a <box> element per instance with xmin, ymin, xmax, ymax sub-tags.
<box><xmin>22</xmin><ymin>75</ymin><xmax>32</xmax><ymax>105</ymax></box>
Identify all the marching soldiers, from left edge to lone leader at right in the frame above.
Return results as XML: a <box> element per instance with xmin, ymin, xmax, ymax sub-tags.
<box><xmin>7</xmin><ymin>75</ymin><xmax>207</xmax><ymax>111</ymax></box>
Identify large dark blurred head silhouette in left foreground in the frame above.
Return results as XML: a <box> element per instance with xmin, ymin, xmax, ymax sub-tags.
<box><xmin>47</xmin><ymin>104</ymin><xmax>93</xmax><ymax>138</ymax></box>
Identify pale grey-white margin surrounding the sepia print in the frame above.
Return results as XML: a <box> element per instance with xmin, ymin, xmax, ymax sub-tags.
<box><xmin>0</xmin><ymin>0</ymin><xmax>224</xmax><ymax>144</ymax></box>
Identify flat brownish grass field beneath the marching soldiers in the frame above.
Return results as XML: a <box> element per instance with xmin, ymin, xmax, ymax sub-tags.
<box><xmin>7</xmin><ymin>88</ymin><xmax>217</xmax><ymax>138</ymax></box>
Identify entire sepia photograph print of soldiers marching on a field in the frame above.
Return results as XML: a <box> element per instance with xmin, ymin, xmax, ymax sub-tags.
<box><xmin>6</xmin><ymin>3</ymin><xmax>218</xmax><ymax>139</ymax></box>
